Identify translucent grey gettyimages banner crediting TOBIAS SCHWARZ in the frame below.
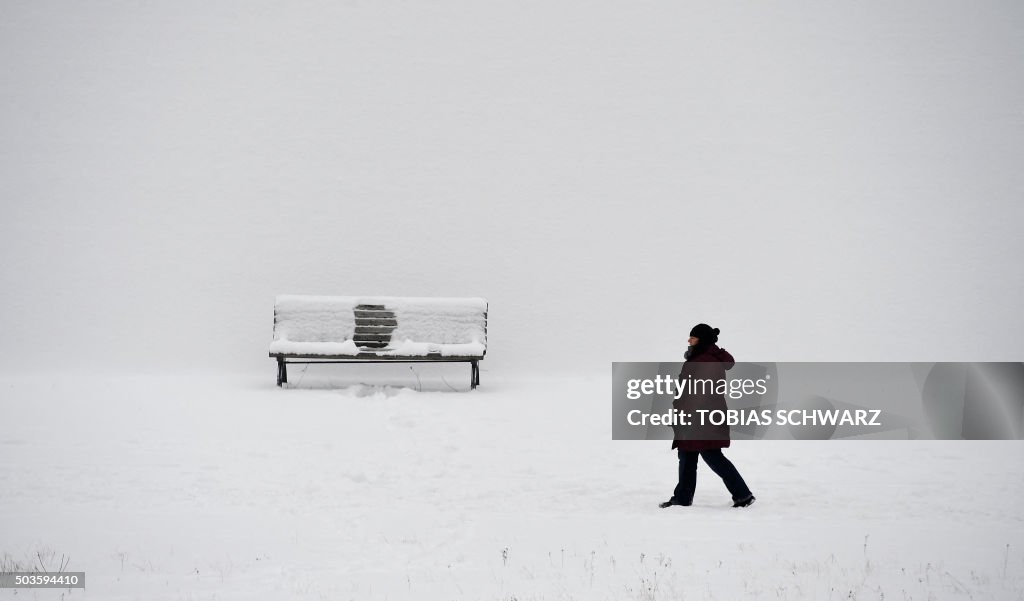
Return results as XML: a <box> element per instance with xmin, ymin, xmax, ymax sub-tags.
<box><xmin>612</xmin><ymin>362</ymin><xmax>1024</xmax><ymax>440</ymax></box>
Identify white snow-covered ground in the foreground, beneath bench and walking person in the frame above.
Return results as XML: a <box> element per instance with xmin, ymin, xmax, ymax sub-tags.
<box><xmin>0</xmin><ymin>374</ymin><xmax>1024</xmax><ymax>601</ymax></box>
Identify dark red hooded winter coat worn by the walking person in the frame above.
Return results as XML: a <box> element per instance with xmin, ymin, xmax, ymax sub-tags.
<box><xmin>672</xmin><ymin>344</ymin><xmax>736</xmax><ymax>450</ymax></box>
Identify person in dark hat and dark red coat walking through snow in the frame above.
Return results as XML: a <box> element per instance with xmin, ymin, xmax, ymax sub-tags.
<box><xmin>659</xmin><ymin>324</ymin><xmax>754</xmax><ymax>508</ymax></box>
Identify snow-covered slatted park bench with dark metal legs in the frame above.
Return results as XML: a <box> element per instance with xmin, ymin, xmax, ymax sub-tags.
<box><xmin>270</xmin><ymin>294</ymin><xmax>487</xmax><ymax>388</ymax></box>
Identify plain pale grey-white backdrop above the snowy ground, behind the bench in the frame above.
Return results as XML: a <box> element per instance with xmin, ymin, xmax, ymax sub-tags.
<box><xmin>0</xmin><ymin>0</ymin><xmax>1024</xmax><ymax>373</ymax></box>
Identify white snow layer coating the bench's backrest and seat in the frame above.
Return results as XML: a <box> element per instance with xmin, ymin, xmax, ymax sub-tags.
<box><xmin>270</xmin><ymin>295</ymin><xmax>487</xmax><ymax>357</ymax></box>
